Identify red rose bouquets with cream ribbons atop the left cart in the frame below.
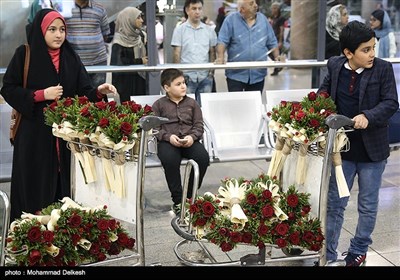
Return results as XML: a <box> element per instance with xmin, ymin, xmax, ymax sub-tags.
<box><xmin>44</xmin><ymin>96</ymin><xmax>153</xmax><ymax>198</ymax></box>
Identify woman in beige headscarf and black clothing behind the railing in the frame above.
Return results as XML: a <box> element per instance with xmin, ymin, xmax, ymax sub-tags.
<box><xmin>110</xmin><ymin>7</ymin><xmax>147</xmax><ymax>103</ymax></box>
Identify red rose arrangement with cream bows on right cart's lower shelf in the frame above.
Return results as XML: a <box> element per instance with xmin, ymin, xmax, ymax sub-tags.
<box><xmin>186</xmin><ymin>174</ymin><xmax>325</xmax><ymax>252</ymax></box>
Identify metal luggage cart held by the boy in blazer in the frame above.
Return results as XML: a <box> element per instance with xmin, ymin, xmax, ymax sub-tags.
<box><xmin>171</xmin><ymin>115</ymin><xmax>353</xmax><ymax>266</ymax></box>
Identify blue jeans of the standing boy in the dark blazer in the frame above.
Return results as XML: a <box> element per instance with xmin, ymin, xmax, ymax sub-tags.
<box><xmin>326</xmin><ymin>160</ymin><xmax>387</xmax><ymax>261</ymax></box>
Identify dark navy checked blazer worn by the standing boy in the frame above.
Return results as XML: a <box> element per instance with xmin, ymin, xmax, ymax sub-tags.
<box><xmin>318</xmin><ymin>56</ymin><xmax>399</xmax><ymax>161</ymax></box>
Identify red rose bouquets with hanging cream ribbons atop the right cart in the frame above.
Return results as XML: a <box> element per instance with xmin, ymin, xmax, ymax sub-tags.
<box><xmin>267</xmin><ymin>91</ymin><xmax>350</xmax><ymax>197</ymax></box>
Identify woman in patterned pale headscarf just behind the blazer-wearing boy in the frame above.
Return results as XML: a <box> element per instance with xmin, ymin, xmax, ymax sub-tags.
<box><xmin>325</xmin><ymin>4</ymin><xmax>349</xmax><ymax>59</ymax></box>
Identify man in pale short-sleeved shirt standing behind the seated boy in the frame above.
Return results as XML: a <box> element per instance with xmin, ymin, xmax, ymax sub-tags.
<box><xmin>171</xmin><ymin>0</ymin><xmax>217</xmax><ymax>106</ymax></box>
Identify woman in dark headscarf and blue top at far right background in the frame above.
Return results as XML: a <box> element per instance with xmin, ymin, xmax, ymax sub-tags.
<box><xmin>369</xmin><ymin>10</ymin><xmax>397</xmax><ymax>58</ymax></box>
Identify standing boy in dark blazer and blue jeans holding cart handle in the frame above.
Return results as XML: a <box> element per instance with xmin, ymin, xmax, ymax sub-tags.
<box><xmin>318</xmin><ymin>21</ymin><xmax>399</xmax><ymax>266</ymax></box>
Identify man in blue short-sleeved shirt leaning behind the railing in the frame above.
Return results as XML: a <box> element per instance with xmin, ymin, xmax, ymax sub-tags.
<box><xmin>215</xmin><ymin>0</ymin><xmax>279</xmax><ymax>92</ymax></box>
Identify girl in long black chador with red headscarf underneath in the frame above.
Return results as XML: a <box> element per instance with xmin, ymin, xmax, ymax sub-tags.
<box><xmin>0</xmin><ymin>9</ymin><xmax>116</xmax><ymax>221</ymax></box>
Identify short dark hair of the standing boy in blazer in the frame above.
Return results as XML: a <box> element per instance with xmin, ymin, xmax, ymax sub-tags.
<box><xmin>339</xmin><ymin>20</ymin><xmax>375</xmax><ymax>53</ymax></box>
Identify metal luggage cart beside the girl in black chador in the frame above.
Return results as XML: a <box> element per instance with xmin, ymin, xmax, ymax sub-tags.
<box><xmin>71</xmin><ymin>116</ymin><xmax>168</xmax><ymax>266</ymax></box>
